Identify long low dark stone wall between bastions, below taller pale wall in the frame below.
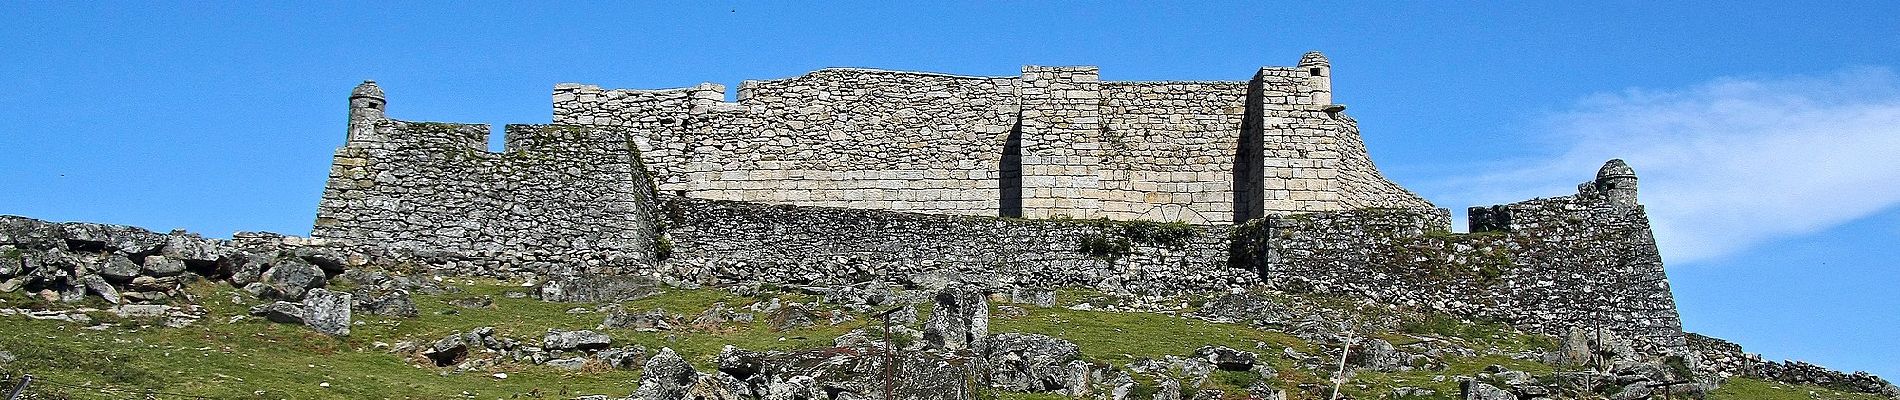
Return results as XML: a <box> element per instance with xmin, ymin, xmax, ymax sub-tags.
<box><xmin>663</xmin><ymin>199</ymin><xmax>1258</xmax><ymax>296</ymax></box>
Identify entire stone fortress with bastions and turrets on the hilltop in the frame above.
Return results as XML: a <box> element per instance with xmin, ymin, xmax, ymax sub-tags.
<box><xmin>312</xmin><ymin>53</ymin><xmax>1685</xmax><ymax>351</ymax></box>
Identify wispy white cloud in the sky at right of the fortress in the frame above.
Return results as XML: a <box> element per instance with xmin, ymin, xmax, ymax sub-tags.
<box><xmin>1431</xmin><ymin>68</ymin><xmax>1900</xmax><ymax>262</ymax></box>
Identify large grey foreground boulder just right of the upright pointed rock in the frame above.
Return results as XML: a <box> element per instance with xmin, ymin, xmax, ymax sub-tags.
<box><xmin>982</xmin><ymin>332</ymin><xmax>1087</xmax><ymax>392</ymax></box>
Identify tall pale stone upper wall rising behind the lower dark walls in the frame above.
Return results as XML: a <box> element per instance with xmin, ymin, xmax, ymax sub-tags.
<box><xmin>553</xmin><ymin>53</ymin><xmax>1435</xmax><ymax>224</ymax></box>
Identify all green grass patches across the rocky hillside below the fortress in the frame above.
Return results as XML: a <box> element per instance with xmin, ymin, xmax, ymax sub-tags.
<box><xmin>0</xmin><ymin>279</ymin><xmax>1875</xmax><ymax>400</ymax></box>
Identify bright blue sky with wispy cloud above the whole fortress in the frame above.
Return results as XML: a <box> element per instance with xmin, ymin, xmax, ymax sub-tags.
<box><xmin>0</xmin><ymin>2</ymin><xmax>1900</xmax><ymax>377</ymax></box>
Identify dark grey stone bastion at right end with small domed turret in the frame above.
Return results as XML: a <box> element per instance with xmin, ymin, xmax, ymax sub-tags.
<box><xmin>1237</xmin><ymin>161</ymin><xmax>1683</xmax><ymax>351</ymax></box>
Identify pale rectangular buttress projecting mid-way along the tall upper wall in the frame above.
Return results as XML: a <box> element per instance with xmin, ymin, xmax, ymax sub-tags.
<box><xmin>1017</xmin><ymin>66</ymin><xmax>1104</xmax><ymax>218</ymax></box>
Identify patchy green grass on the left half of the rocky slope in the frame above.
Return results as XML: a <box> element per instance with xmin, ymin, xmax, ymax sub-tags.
<box><xmin>0</xmin><ymin>279</ymin><xmax>863</xmax><ymax>398</ymax></box>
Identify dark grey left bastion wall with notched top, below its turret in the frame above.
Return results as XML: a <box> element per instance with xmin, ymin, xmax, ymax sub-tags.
<box><xmin>312</xmin><ymin>119</ymin><xmax>656</xmax><ymax>262</ymax></box>
